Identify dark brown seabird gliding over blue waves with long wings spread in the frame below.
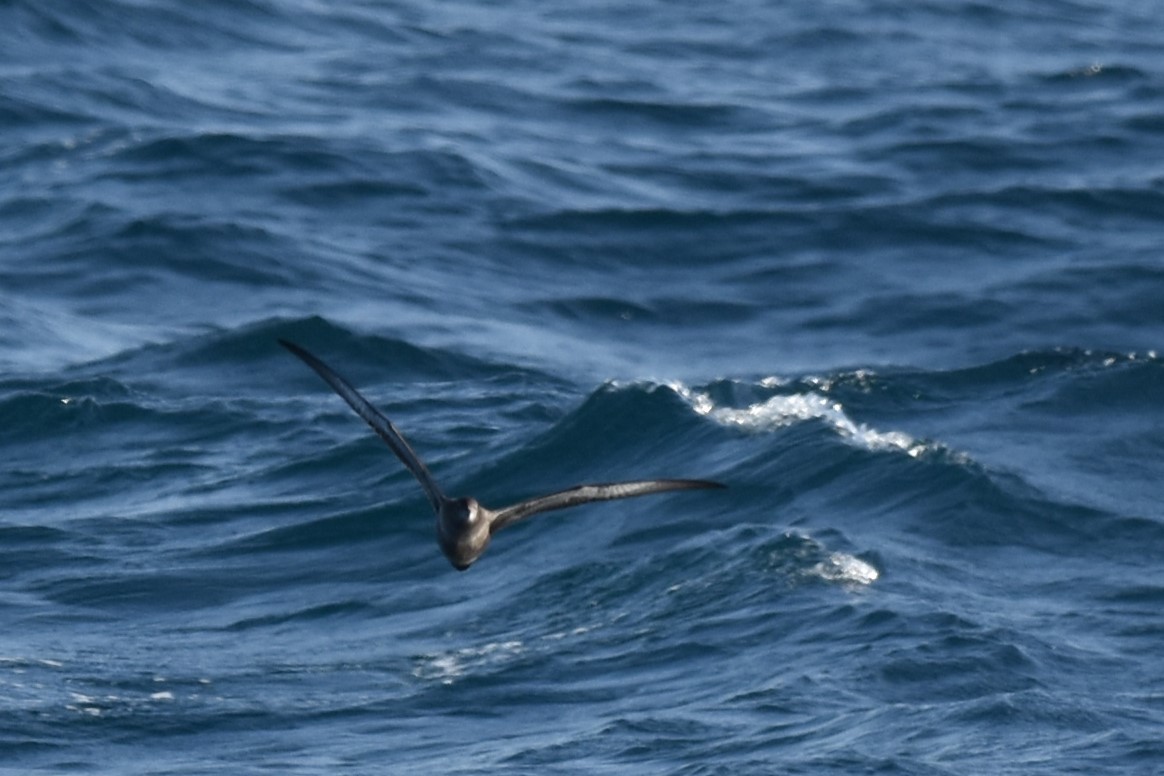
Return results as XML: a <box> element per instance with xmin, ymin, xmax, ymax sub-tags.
<box><xmin>279</xmin><ymin>340</ymin><xmax>724</xmax><ymax>571</ymax></box>
